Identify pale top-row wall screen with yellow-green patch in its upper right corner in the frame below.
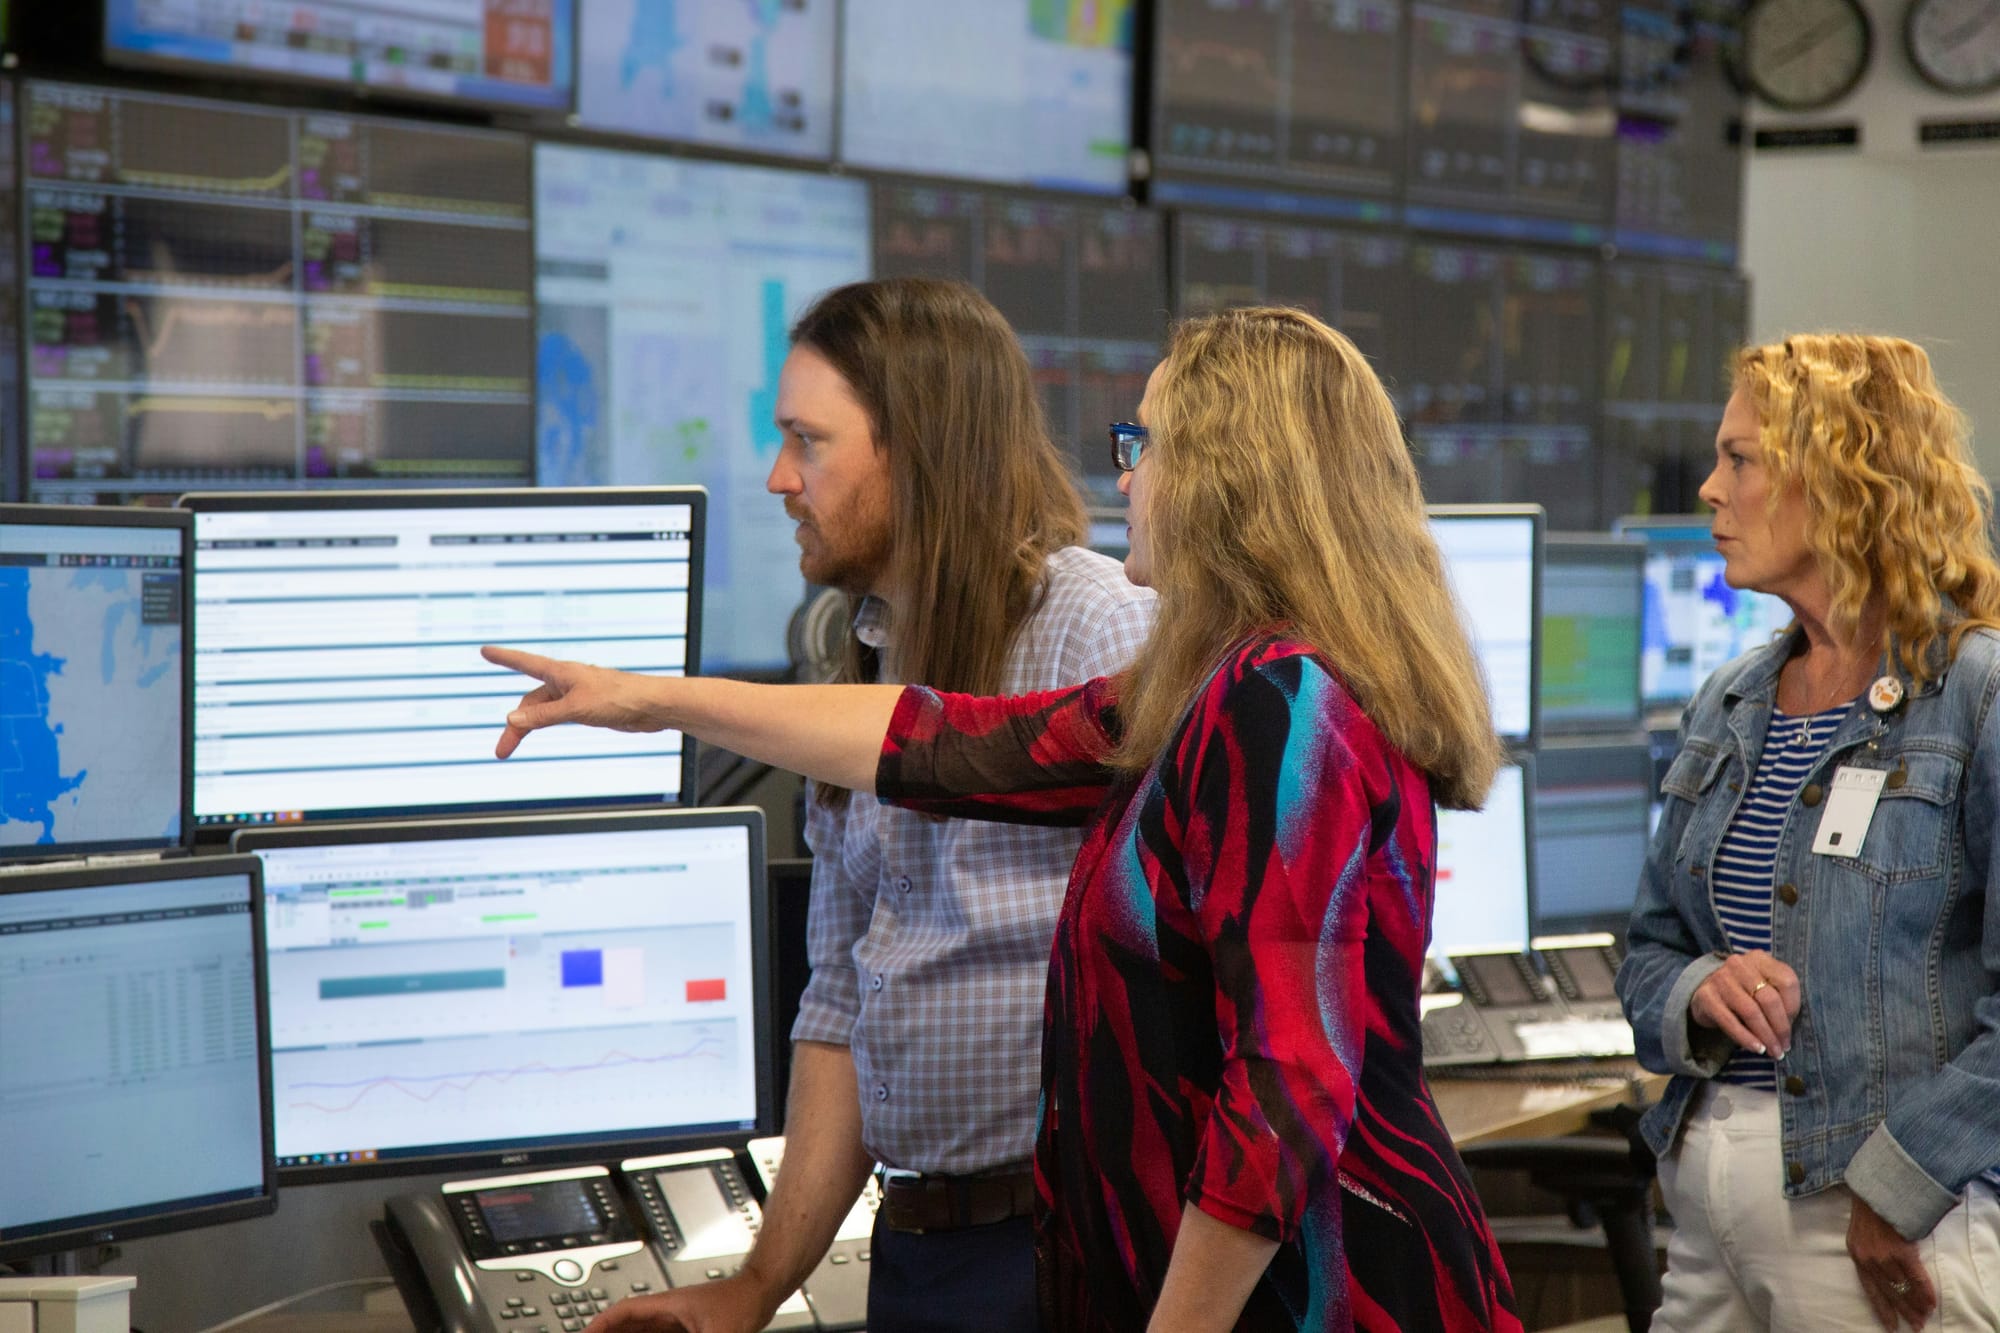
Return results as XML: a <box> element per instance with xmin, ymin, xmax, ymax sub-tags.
<box><xmin>840</xmin><ymin>0</ymin><xmax>1134</xmax><ymax>194</ymax></box>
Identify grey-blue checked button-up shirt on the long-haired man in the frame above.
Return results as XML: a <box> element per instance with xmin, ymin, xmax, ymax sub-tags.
<box><xmin>792</xmin><ymin>546</ymin><xmax>1154</xmax><ymax>1175</ymax></box>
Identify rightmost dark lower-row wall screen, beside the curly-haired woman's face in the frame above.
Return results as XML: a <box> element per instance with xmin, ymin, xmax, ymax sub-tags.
<box><xmin>1600</xmin><ymin>260</ymin><xmax>1750</xmax><ymax>516</ymax></box>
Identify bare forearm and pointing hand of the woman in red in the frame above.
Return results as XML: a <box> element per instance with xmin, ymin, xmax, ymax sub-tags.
<box><xmin>480</xmin><ymin>646</ymin><xmax>902</xmax><ymax>793</ymax></box>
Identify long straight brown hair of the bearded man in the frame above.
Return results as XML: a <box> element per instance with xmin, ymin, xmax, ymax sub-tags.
<box><xmin>792</xmin><ymin>278</ymin><xmax>1086</xmax><ymax>788</ymax></box>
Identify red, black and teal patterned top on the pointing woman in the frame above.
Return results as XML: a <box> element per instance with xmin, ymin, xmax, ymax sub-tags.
<box><xmin>876</xmin><ymin>636</ymin><xmax>1522</xmax><ymax>1333</ymax></box>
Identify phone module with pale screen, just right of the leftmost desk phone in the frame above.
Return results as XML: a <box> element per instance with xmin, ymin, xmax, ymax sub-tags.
<box><xmin>618</xmin><ymin>1149</ymin><xmax>814</xmax><ymax>1329</ymax></box>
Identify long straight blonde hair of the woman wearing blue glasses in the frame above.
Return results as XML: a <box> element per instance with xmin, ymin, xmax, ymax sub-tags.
<box><xmin>1118</xmin><ymin>308</ymin><xmax>1502</xmax><ymax>809</ymax></box>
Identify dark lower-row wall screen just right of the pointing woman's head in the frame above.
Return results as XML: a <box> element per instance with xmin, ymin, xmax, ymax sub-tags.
<box><xmin>1400</xmin><ymin>238</ymin><xmax>1602</xmax><ymax>528</ymax></box>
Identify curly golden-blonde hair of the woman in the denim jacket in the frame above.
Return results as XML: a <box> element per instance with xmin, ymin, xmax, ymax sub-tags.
<box><xmin>1734</xmin><ymin>334</ymin><xmax>2000</xmax><ymax>685</ymax></box>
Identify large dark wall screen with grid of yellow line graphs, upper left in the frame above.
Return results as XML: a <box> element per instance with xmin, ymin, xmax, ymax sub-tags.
<box><xmin>22</xmin><ymin>82</ymin><xmax>534</xmax><ymax>500</ymax></box>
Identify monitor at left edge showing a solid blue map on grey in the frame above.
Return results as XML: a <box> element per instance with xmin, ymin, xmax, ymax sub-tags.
<box><xmin>0</xmin><ymin>504</ymin><xmax>194</xmax><ymax>861</ymax></box>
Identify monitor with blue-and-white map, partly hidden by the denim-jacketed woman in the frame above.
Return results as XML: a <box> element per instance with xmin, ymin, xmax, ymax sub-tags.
<box><xmin>1612</xmin><ymin>514</ymin><xmax>1792</xmax><ymax>713</ymax></box>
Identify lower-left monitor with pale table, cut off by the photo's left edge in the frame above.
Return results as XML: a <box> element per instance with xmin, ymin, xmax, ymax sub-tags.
<box><xmin>0</xmin><ymin>857</ymin><xmax>276</xmax><ymax>1261</ymax></box>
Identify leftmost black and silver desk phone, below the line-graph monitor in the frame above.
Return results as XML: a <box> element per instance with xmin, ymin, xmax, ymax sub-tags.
<box><xmin>384</xmin><ymin>1167</ymin><xmax>668</xmax><ymax>1333</ymax></box>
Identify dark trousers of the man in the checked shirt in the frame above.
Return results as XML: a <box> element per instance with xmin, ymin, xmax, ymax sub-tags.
<box><xmin>868</xmin><ymin>1217</ymin><xmax>1036</xmax><ymax>1333</ymax></box>
